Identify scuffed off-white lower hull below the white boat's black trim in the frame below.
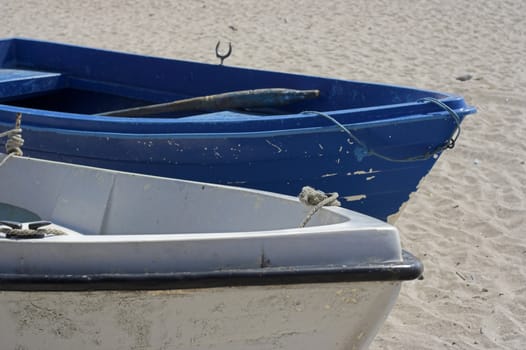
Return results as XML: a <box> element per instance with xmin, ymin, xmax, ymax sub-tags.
<box><xmin>0</xmin><ymin>281</ymin><xmax>400</xmax><ymax>350</ymax></box>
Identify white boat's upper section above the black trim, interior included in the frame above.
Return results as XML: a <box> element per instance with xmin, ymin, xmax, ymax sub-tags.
<box><xmin>0</xmin><ymin>155</ymin><xmax>402</xmax><ymax>274</ymax></box>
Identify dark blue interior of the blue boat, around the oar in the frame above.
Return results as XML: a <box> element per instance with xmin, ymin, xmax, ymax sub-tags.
<box><xmin>0</xmin><ymin>39</ymin><xmax>447</xmax><ymax>121</ymax></box>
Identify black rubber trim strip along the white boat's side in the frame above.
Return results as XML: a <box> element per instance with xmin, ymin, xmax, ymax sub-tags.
<box><xmin>0</xmin><ymin>251</ymin><xmax>424</xmax><ymax>291</ymax></box>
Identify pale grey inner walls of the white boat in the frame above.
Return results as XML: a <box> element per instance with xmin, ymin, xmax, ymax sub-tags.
<box><xmin>0</xmin><ymin>157</ymin><xmax>350</xmax><ymax>235</ymax></box>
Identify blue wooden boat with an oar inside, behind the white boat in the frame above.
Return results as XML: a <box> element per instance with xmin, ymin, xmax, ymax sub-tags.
<box><xmin>0</xmin><ymin>38</ymin><xmax>475</xmax><ymax>220</ymax></box>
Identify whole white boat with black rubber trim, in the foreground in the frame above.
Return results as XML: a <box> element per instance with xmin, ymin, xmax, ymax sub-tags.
<box><xmin>0</xmin><ymin>154</ymin><xmax>422</xmax><ymax>350</ymax></box>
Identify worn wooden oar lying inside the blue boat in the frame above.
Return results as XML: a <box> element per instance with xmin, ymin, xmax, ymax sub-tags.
<box><xmin>98</xmin><ymin>88</ymin><xmax>320</xmax><ymax>117</ymax></box>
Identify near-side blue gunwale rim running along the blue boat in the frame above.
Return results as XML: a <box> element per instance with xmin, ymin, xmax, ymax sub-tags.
<box><xmin>0</xmin><ymin>98</ymin><xmax>474</xmax><ymax>139</ymax></box>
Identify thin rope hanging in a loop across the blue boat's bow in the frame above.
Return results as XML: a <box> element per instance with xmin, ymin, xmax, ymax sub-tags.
<box><xmin>302</xmin><ymin>97</ymin><xmax>461</xmax><ymax>163</ymax></box>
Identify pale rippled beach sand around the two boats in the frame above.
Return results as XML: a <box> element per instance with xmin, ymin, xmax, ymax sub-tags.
<box><xmin>0</xmin><ymin>0</ymin><xmax>526</xmax><ymax>350</ymax></box>
